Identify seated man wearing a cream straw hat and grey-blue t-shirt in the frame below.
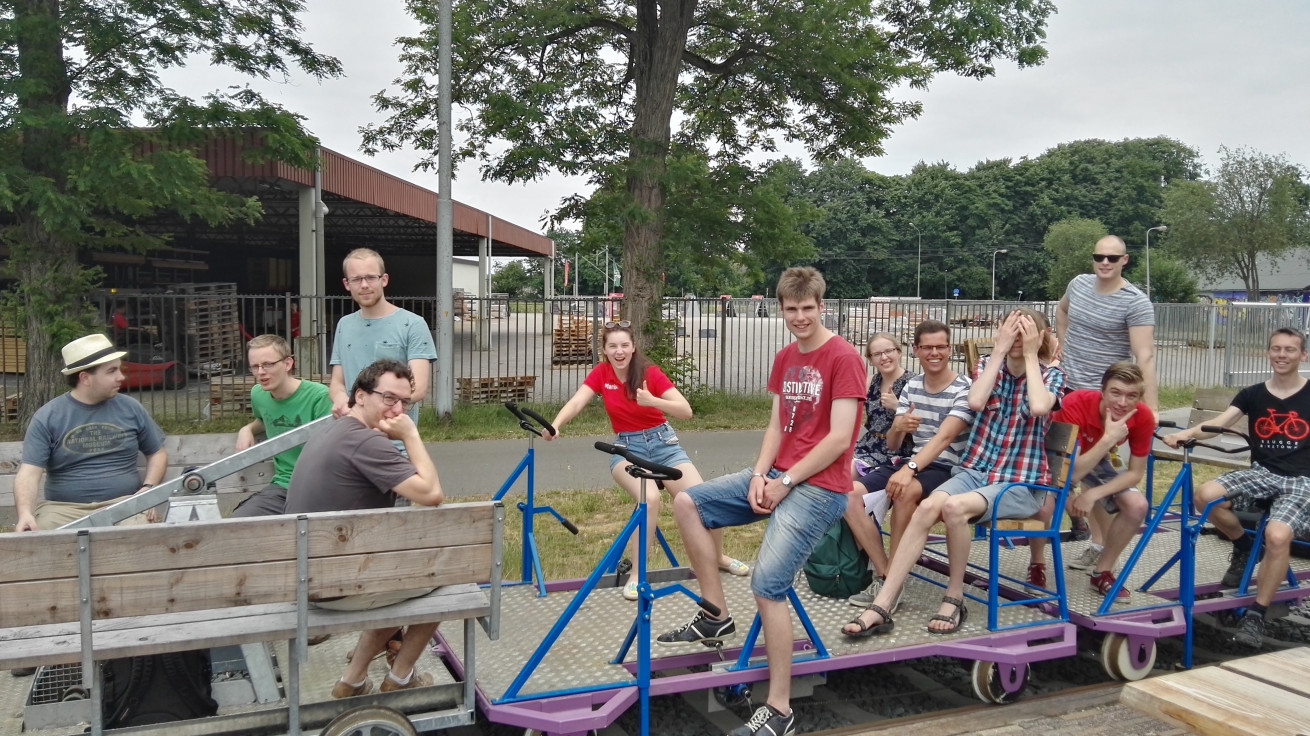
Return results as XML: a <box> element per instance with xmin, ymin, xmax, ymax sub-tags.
<box><xmin>13</xmin><ymin>335</ymin><xmax>168</xmax><ymax>532</ymax></box>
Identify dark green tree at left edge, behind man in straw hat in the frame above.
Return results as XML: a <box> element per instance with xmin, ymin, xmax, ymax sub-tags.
<box><xmin>0</xmin><ymin>0</ymin><xmax>341</xmax><ymax>422</ymax></box>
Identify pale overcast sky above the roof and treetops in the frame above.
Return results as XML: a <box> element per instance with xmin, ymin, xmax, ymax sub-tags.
<box><xmin>170</xmin><ymin>0</ymin><xmax>1310</xmax><ymax>229</ymax></box>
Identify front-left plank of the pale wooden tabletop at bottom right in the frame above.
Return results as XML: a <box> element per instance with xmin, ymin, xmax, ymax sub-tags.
<box><xmin>1119</xmin><ymin>667</ymin><xmax>1310</xmax><ymax>736</ymax></box>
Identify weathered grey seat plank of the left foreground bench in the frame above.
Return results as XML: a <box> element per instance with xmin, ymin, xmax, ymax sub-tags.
<box><xmin>0</xmin><ymin>584</ymin><xmax>491</xmax><ymax>669</ymax></box>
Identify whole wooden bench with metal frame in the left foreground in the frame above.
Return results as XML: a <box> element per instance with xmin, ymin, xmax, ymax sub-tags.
<box><xmin>0</xmin><ymin>502</ymin><xmax>503</xmax><ymax>733</ymax></box>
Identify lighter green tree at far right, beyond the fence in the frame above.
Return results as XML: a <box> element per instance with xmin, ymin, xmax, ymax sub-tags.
<box><xmin>1162</xmin><ymin>148</ymin><xmax>1310</xmax><ymax>299</ymax></box>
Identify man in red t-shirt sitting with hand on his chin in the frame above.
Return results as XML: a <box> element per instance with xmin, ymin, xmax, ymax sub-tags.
<box><xmin>1028</xmin><ymin>360</ymin><xmax>1155</xmax><ymax>601</ymax></box>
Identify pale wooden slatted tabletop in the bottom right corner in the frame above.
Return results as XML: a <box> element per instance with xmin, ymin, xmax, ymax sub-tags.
<box><xmin>1119</xmin><ymin>647</ymin><xmax>1310</xmax><ymax>736</ymax></box>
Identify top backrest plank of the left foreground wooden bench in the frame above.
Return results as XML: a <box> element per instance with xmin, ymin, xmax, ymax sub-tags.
<box><xmin>0</xmin><ymin>503</ymin><xmax>495</xmax><ymax>583</ymax></box>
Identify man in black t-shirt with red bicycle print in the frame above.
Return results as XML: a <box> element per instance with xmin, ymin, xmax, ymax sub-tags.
<box><xmin>1165</xmin><ymin>327</ymin><xmax>1310</xmax><ymax>647</ymax></box>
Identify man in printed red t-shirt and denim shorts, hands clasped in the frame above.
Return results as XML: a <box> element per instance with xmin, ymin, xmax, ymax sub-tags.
<box><xmin>656</xmin><ymin>267</ymin><xmax>866</xmax><ymax>736</ymax></box>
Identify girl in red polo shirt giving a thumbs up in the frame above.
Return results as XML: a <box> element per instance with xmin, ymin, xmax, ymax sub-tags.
<box><xmin>544</xmin><ymin>321</ymin><xmax>751</xmax><ymax>601</ymax></box>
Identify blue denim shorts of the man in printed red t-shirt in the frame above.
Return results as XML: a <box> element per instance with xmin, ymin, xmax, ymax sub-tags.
<box><xmin>686</xmin><ymin>468</ymin><xmax>846</xmax><ymax>601</ymax></box>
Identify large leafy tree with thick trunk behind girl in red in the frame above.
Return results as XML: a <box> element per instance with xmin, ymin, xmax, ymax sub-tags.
<box><xmin>364</xmin><ymin>0</ymin><xmax>1055</xmax><ymax>337</ymax></box>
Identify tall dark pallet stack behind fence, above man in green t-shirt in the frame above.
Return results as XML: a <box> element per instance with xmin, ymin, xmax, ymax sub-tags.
<box><xmin>172</xmin><ymin>283</ymin><xmax>245</xmax><ymax>376</ymax></box>
